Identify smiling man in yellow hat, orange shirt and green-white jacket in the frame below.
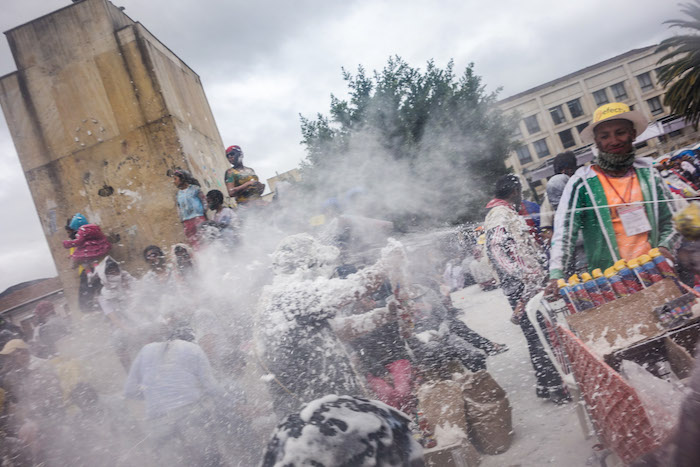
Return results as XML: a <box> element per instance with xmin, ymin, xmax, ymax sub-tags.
<box><xmin>549</xmin><ymin>102</ymin><xmax>677</xmax><ymax>291</ymax></box>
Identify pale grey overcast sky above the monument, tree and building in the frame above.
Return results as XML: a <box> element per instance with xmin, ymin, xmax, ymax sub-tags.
<box><xmin>0</xmin><ymin>0</ymin><xmax>681</xmax><ymax>291</ymax></box>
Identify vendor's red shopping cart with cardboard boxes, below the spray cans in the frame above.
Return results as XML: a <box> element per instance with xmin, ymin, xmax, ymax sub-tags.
<box><xmin>529</xmin><ymin>268</ymin><xmax>700</xmax><ymax>465</ymax></box>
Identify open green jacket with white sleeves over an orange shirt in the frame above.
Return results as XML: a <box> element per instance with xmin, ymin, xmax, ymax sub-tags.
<box><xmin>549</xmin><ymin>157</ymin><xmax>678</xmax><ymax>279</ymax></box>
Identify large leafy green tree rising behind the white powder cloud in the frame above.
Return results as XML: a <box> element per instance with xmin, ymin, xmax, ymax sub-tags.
<box><xmin>301</xmin><ymin>57</ymin><xmax>513</xmax><ymax>229</ymax></box>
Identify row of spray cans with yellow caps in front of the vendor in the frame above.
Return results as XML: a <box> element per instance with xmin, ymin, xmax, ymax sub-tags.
<box><xmin>559</xmin><ymin>248</ymin><xmax>676</xmax><ymax>313</ymax></box>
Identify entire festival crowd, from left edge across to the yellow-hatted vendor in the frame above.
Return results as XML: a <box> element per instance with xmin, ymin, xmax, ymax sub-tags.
<box><xmin>0</xmin><ymin>103</ymin><xmax>700</xmax><ymax>466</ymax></box>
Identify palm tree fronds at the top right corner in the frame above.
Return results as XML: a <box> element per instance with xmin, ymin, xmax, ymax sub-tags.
<box><xmin>656</xmin><ymin>2</ymin><xmax>700</xmax><ymax>127</ymax></box>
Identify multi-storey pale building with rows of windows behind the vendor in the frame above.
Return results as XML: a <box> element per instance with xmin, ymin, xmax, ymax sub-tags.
<box><xmin>499</xmin><ymin>45</ymin><xmax>700</xmax><ymax>196</ymax></box>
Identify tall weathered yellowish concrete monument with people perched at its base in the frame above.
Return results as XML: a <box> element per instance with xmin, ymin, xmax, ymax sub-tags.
<box><xmin>0</xmin><ymin>0</ymin><xmax>228</xmax><ymax>314</ymax></box>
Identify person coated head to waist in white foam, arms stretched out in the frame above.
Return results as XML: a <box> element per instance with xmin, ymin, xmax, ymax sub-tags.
<box><xmin>256</xmin><ymin>234</ymin><xmax>405</xmax><ymax>418</ymax></box>
